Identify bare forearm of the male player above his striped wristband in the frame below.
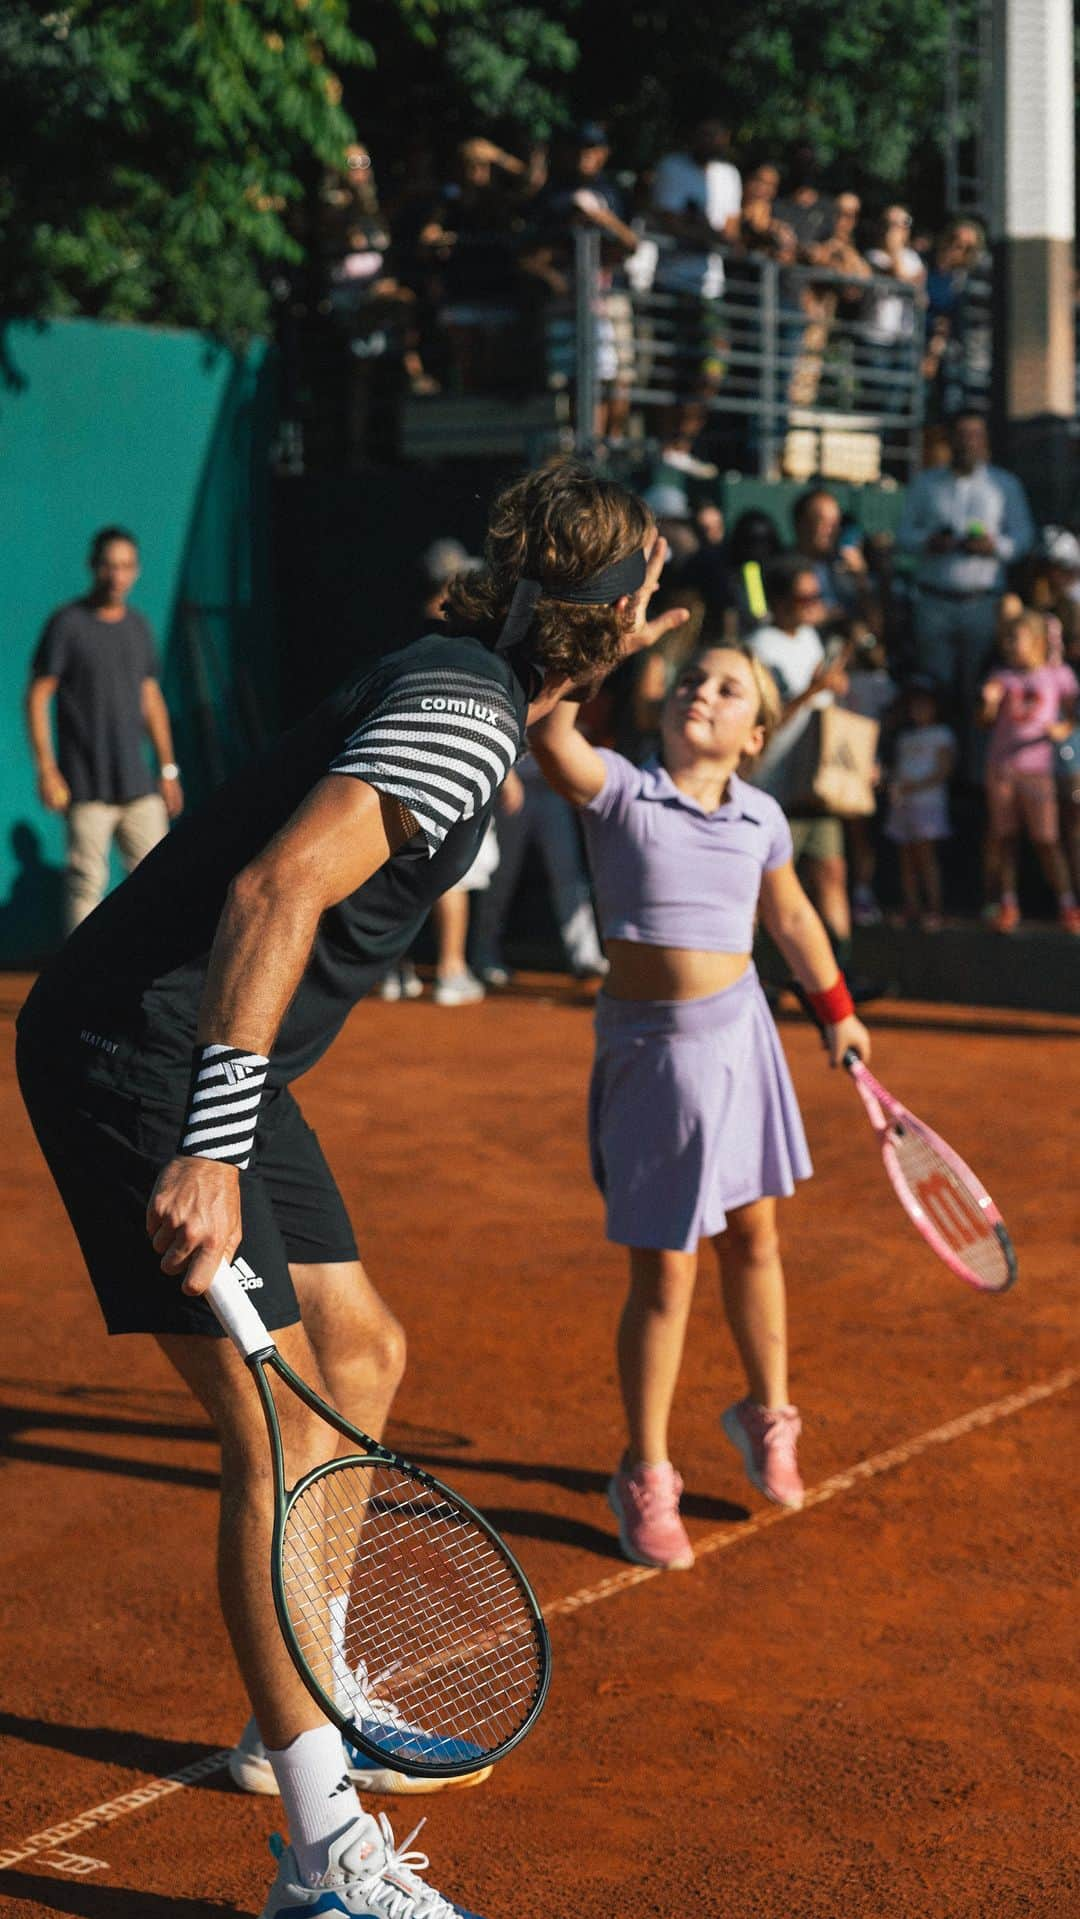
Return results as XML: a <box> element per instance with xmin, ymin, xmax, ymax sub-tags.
<box><xmin>198</xmin><ymin>867</ymin><xmax>322</xmax><ymax>1059</ymax></box>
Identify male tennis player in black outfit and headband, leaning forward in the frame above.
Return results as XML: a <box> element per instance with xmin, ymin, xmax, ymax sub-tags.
<box><xmin>19</xmin><ymin>464</ymin><xmax>685</xmax><ymax>1919</ymax></box>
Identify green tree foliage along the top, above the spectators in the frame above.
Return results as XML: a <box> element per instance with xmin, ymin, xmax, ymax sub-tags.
<box><xmin>0</xmin><ymin>0</ymin><xmax>978</xmax><ymax>340</ymax></box>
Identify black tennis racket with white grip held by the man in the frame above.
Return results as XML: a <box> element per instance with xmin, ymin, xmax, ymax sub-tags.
<box><xmin>205</xmin><ymin>1265</ymin><xmax>551</xmax><ymax>1779</ymax></box>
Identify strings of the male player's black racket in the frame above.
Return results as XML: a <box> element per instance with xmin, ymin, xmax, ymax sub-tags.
<box><xmin>282</xmin><ymin>1462</ymin><xmax>543</xmax><ymax>1764</ymax></box>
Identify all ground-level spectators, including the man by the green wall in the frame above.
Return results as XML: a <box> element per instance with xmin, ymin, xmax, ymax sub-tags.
<box><xmin>27</xmin><ymin>435</ymin><xmax>1080</xmax><ymax>1006</ymax></box>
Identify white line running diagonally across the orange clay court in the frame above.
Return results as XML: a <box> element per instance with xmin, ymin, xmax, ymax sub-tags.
<box><xmin>0</xmin><ymin>1366</ymin><xmax>1080</xmax><ymax>1869</ymax></box>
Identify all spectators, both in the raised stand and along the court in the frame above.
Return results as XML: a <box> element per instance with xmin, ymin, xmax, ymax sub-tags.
<box><xmin>27</xmin><ymin>121</ymin><xmax>1080</xmax><ymax>1006</ymax></box>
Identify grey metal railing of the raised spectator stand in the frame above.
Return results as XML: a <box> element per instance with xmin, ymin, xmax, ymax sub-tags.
<box><xmin>574</xmin><ymin>228</ymin><xmax>925</xmax><ymax>480</ymax></box>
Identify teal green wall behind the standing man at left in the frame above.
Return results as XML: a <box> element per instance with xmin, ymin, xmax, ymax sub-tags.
<box><xmin>0</xmin><ymin>320</ymin><xmax>276</xmax><ymax>965</ymax></box>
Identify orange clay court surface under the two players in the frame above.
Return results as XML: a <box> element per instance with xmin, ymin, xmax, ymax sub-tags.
<box><xmin>0</xmin><ymin>975</ymin><xmax>1080</xmax><ymax>1919</ymax></box>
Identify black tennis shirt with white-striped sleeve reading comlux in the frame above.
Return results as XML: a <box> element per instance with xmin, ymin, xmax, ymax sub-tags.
<box><xmin>19</xmin><ymin>635</ymin><xmax>528</xmax><ymax>1102</ymax></box>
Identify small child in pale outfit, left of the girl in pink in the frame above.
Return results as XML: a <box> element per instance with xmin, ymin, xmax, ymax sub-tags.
<box><xmin>884</xmin><ymin>679</ymin><xmax>955</xmax><ymax>933</ymax></box>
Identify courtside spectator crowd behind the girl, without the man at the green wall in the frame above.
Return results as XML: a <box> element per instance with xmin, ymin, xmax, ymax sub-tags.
<box><xmin>386</xmin><ymin>437</ymin><xmax>1080</xmax><ymax>1006</ymax></box>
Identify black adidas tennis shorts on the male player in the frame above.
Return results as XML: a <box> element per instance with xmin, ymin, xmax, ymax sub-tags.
<box><xmin>15</xmin><ymin>1032</ymin><xmax>359</xmax><ymax>1336</ymax></box>
